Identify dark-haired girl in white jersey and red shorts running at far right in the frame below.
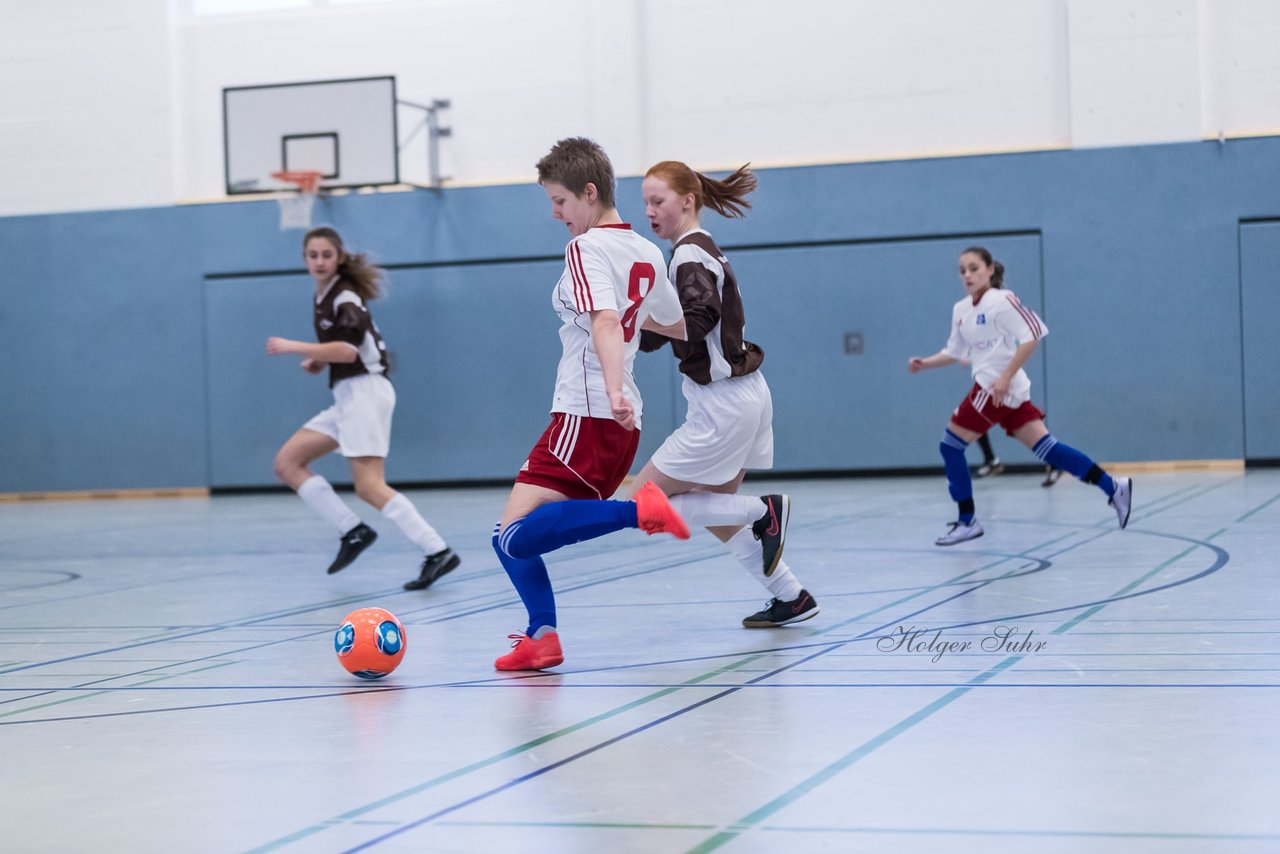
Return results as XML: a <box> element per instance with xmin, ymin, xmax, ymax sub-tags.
<box><xmin>908</xmin><ymin>246</ymin><xmax>1133</xmax><ymax>545</ymax></box>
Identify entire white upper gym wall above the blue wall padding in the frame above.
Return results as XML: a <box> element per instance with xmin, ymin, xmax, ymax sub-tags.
<box><xmin>0</xmin><ymin>0</ymin><xmax>1280</xmax><ymax>215</ymax></box>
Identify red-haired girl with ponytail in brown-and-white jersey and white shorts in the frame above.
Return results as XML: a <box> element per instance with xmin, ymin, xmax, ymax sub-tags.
<box><xmin>636</xmin><ymin>160</ymin><xmax>818</xmax><ymax>629</ymax></box>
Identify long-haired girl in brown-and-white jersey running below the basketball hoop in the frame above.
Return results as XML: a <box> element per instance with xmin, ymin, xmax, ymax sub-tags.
<box><xmin>266</xmin><ymin>227</ymin><xmax>461</xmax><ymax>590</ymax></box>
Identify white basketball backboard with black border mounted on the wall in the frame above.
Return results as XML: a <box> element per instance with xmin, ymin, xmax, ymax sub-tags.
<box><xmin>223</xmin><ymin>77</ymin><xmax>399</xmax><ymax>196</ymax></box>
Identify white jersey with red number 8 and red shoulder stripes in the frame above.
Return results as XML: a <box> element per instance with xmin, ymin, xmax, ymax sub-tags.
<box><xmin>552</xmin><ymin>223</ymin><xmax>684</xmax><ymax>429</ymax></box>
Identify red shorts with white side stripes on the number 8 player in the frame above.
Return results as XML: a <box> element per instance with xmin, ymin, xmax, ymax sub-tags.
<box><xmin>516</xmin><ymin>412</ymin><xmax>640</xmax><ymax>498</ymax></box>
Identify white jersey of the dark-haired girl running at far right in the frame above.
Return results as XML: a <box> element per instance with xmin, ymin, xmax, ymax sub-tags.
<box><xmin>942</xmin><ymin>288</ymin><xmax>1048</xmax><ymax>407</ymax></box>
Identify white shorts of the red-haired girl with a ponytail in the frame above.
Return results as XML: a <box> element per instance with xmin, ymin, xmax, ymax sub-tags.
<box><xmin>653</xmin><ymin>371</ymin><xmax>773</xmax><ymax>487</ymax></box>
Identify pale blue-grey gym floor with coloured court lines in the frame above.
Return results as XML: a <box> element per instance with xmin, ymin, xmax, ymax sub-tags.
<box><xmin>0</xmin><ymin>470</ymin><xmax>1280</xmax><ymax>854</ymax></box>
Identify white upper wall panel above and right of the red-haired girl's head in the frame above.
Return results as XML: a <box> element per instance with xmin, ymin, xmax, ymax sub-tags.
<box><xmin>646</xmin><ymin>0</ymin><xmax>1069</xmax><ymax>164</ymax></box>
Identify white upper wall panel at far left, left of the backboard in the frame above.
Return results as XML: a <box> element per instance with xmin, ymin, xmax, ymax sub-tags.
<box><xmin>0</xmin><ymin>0</ymin><xmax>174</xmax><ymax>214</ymax></box>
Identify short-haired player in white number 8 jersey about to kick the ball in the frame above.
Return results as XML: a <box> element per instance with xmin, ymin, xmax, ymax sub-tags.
<box><xmin>493</xmin><ymin>137</ymin><xmax>689</xmax><ymax>670</ymax></box>
